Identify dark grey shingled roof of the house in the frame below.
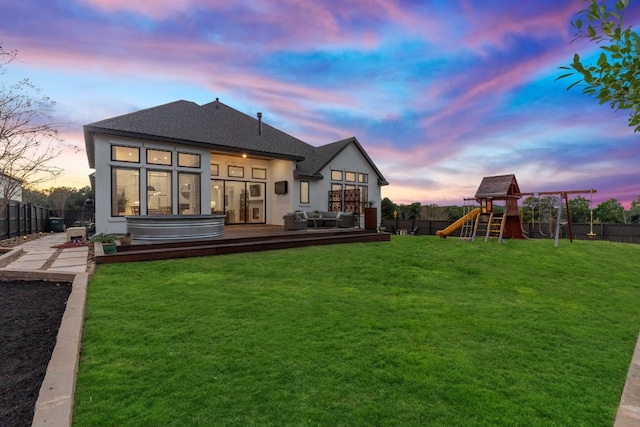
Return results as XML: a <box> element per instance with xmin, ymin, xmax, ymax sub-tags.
<box><xmin>84</xmin><ymin>99</ymin><xmax>387</xmax><ymax>185</ymax></box>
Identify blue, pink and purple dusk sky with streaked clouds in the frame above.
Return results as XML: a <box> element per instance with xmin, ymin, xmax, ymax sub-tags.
<box><xmin>0</xmin><ymin>0</ymin><xmax>640</xmax><ymax>208</ymax></box>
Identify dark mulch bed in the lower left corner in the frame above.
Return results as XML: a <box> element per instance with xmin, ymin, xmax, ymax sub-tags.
<box><xmin>0</xmin><ymin>280</ymin><xmax>71</xmax><ymax>427</ymax></box>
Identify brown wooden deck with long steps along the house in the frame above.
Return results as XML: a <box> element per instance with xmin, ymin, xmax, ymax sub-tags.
<box><xmin>96</xmin><ymin>225</ymin><xmax>391</xmax><ymax>264</ymax></box>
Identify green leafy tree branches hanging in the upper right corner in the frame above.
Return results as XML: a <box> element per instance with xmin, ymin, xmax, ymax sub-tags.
<box><xmin>556</xmin><ymin>0</ymin><xmax>640</xmax><ymax>132</ymax></box>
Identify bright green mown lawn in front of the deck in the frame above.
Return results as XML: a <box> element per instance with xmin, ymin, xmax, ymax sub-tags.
<box><xmin>74</xmin><ymin>236</ymin><xmax>640</xmax><ymax>426</ymax></box>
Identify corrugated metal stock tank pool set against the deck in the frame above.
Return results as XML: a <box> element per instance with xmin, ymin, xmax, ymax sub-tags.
<box><xmin>125</xmin><ymin>215</ymin><xmax>224</xmax><ymax>241</ymax></box>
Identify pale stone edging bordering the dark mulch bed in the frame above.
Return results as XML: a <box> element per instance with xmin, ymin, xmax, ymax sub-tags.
<box><xmin>2</xmin><ymin>270</ymin><xmax>89</xmax><ymax>427</ymax></box>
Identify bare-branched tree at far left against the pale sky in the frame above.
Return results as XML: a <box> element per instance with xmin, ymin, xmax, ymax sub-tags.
<box><xmin>0</xmin><ymin>44</ymin><xmax>62</xmax><ymax>212</ymax></box>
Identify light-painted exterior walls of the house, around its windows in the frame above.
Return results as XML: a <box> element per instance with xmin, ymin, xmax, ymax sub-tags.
<box><xmin>94</xmin><ymin>134</ymin><xmax>381</xmax><ymax>234</ymax></box>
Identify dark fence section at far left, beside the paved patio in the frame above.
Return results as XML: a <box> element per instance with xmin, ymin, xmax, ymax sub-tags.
<box><xmin>0</xmin><ymin>201</ymin><xmax>50</xmax><ymax>239</ymax></box>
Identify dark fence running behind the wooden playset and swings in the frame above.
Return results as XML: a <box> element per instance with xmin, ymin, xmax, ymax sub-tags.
<box><xmin>382</xmin><ymin>219</ymin><xmax>640</xmax><ymax>244</ymax></box>
